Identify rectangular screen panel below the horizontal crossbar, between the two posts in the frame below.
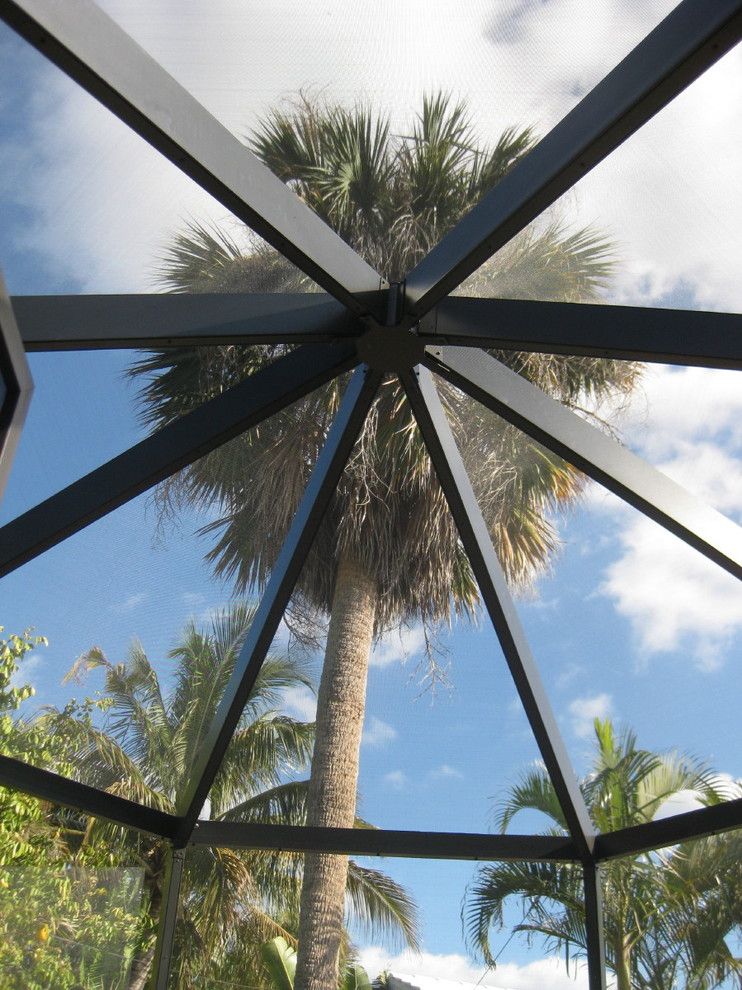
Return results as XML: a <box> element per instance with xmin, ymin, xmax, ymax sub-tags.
<box><xmin>170</xmin><ymin>847</ymin><xmax>586</xmax><ymax>990</ymax></box>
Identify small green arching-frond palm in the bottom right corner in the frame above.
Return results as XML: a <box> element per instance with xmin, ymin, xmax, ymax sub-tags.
<box><xmin>464</xmin><ymin>720</ymin><xmax>742</xmax><ymax>990</ymax></box>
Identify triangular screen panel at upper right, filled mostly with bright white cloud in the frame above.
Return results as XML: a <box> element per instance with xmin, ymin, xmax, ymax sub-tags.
<box><xmin>462</xmin><ymin>40</ymin><xmax>742</xmax><ymax>313</ymax></box>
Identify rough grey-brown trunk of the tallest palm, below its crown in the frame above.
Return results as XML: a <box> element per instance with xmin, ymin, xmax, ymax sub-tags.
<box><xmin>294</xmin><ymin>557</ymin><xmax>378</xmax><ymax>990</ymax></box>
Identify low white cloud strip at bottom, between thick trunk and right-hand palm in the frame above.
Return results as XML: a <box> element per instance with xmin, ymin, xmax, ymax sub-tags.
<box><xmin>360</xmin><ymin>946</ymin><xmax>588</xmax><ymax>990</ymax></box>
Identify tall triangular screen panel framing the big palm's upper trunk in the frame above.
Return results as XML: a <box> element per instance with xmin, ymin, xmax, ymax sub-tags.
<box><xmin>210</xmin><ymin>379</ymin><xmax>556</xmax><ymax>832</ymax></box>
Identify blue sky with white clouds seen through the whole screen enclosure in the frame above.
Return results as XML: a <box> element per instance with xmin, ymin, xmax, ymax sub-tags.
<box><xmin>0</xmin><ymin>0</ymin><xmax>742</xmax><ymax>990</ymax></box>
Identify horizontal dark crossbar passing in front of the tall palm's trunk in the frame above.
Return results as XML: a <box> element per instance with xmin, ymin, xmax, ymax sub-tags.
<box><xmin>191</xmin><ymin>821</ymin><xmax>579</xmax><ymax>862</ymax></box>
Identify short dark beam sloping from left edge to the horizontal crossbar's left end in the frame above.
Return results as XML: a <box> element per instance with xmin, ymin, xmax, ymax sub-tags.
<box><xmin>0</xmin><ymin>755</ymin><xmax>177</xmax><ymax>838</ymax></box>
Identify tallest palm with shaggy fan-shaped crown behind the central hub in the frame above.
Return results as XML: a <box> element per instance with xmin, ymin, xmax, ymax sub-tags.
<box><xmin>131</xmin><ymin>96</ymin><xmax>638</xmax><ymax>990</ymax></box>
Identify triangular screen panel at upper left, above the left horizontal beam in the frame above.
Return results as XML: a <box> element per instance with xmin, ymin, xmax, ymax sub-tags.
<box><xmin>0</xmin><ymin>25</ymin><xmax>316</xmax><ymax>293</ymax></box>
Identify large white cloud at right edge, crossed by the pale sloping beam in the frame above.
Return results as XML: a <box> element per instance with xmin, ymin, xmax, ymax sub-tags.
<box><xmin>586</xmin><ymin>367</ymin><xmax>742</xmax><ymax>671</ymax></box>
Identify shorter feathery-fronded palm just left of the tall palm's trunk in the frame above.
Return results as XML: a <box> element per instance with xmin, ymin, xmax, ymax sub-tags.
<box><xmin>39</xmin><ymin>603</ymin><xmax>416</xmax><ymax>990</ymax></box>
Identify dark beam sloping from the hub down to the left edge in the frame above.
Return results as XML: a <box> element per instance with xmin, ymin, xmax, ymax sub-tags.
<box><xmin>0</xmin><ymin>344</ymin><xmax>357</xmax><ymax>577</ymax></box>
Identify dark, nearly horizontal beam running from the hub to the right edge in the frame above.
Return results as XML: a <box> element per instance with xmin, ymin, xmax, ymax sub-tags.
<box><xmin>422</xmin><ymin>296</ymin><xmax>742</xmax><ymax>368</ymax></box>
